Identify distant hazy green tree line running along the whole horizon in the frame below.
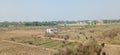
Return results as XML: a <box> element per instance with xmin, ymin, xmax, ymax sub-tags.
<box><xmin>0</xmin><ymin>19</ymin><xmax>120</xmax><ymax>27</ymax></box>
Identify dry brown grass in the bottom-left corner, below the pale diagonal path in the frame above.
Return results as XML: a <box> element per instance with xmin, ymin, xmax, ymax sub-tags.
<box><xmin>0</xmin><ymin>41</ymin><xmax>51</xmax><ymax>55</ymax></box>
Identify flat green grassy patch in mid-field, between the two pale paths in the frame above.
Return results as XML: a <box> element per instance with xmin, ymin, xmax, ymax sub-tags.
<box><xmin>7</xmin><ymin>37</ymin><xmax>77</xmax><ymax>49</ymax></box>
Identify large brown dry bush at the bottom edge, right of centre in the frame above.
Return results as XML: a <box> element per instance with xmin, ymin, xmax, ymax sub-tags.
<box><xmin>53</xmin><ymin>39</ymin><xmax>101</xmax><ymax>55</ymax></box>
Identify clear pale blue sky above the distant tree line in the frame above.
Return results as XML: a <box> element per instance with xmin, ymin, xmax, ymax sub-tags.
<box><xmin>0</xmin><ymin>0</ymin><xmax>120</xmax><ymax>21</ymax></box>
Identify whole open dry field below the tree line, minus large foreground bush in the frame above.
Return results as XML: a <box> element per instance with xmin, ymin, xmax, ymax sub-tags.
<box><xmin>0</xmin><ymin>24</ymin><xmax>120</xmax><ymax>55</ymax></box>
